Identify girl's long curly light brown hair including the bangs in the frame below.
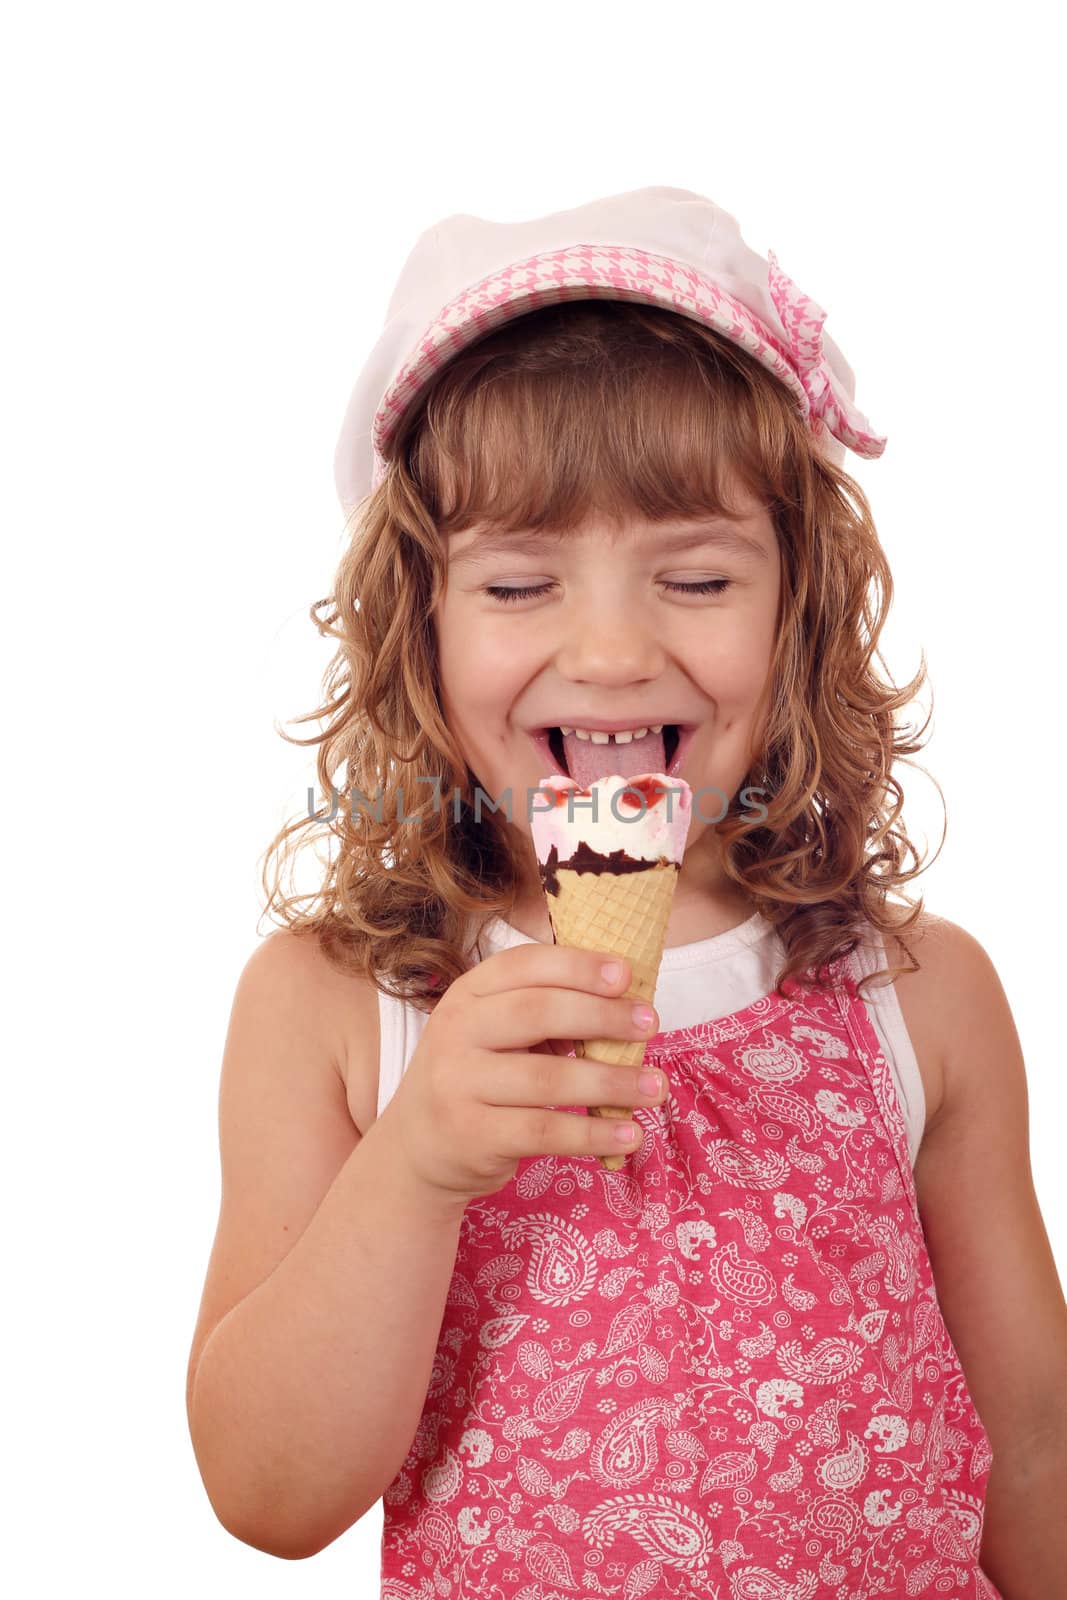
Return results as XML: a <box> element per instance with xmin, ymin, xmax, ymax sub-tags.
<box><xmin>261</xmin><ymin>299</ymin><xmax>944</xmax><ymax>1011</ymax></box>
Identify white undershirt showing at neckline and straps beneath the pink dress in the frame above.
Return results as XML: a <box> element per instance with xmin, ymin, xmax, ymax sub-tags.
<box><xmin>378</xmin><ymin>912</ymin><xmax>926</xmax><ymax>1166</ymax></box>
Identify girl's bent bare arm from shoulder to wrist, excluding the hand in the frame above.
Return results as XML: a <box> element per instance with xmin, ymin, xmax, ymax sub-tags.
<box><xmin>186</xmin><ymin>931</ymin><xmax>462</xmax><ymax>1558</ymax></box>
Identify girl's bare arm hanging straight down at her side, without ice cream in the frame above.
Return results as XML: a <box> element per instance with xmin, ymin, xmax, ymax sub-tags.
<box><xmin>915</xmin><ymin>920</ymin><xmax>1067</xmax><ymax>1600</ymax></box>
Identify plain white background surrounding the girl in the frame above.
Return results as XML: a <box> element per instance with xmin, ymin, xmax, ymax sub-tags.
<box><xmin>0</xmin><ymin>0</ymin><xmax>1067</xmax><ymax>1600</ymax></box>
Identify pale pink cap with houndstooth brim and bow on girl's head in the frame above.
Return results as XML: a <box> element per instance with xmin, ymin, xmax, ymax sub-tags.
<box><xmin>334</xmin><ymin>189</ymin><xmax>886</xmax><ymax>517</ymax></box>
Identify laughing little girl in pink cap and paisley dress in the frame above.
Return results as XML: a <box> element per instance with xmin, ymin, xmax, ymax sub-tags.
<box><xmin>189</xmin><ymin>189</ymin><xmax>1067</xmax><ymax>1600</ymax></box>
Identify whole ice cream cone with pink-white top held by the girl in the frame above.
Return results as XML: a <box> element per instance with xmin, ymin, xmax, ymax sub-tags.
<box><xmin>531</xmin><ymin>773</ymin><xmax>691</xmax><ymax>1171</ymax></box>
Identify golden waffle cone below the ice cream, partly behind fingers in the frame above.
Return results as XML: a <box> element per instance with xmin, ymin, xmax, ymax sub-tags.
<box><xmin>545</xmin><ymin>861</ymin><xmax>678</xmax><ymax>1171</ymax></box>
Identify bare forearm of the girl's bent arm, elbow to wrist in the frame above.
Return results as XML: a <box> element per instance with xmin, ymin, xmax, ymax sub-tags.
<box><xmin>190</xmin><ymin>1115</ymin><xmax>462</xmax><ymax>1558</ymax></box>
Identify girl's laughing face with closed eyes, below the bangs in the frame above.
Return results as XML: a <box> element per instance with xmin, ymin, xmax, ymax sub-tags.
<box><xmin>434</xmin><ymin>473</ymin><xmax>781</xmax><ymax>908</ymax></box>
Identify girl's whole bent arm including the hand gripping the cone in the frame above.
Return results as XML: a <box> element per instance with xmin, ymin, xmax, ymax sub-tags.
<box><xmin>187</xmin><ymin>938</ymin><xmax>665</xmax><ymax>1558</ymax></box>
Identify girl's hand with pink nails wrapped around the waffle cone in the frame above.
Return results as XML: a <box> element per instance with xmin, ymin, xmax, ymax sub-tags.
<box><xmin>378</xmin><ymin>944</ymin><xmax>665</xmax><ymax>1203</ymax></box>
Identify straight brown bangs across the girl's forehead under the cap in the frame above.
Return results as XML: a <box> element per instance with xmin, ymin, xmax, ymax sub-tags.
<box><xmin>395</xmin><ymin>299</ymin><xmax>811</xmax><ymax>538</ymax></box>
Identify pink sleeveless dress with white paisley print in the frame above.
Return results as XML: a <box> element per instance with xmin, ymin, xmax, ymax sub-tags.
<box><xmin>381</xmin><ymin>960</ymin><xmax>1001</xmax><ymax>1600</ymax></box>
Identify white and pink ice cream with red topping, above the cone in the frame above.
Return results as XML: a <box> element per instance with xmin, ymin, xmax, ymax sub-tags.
<box><xmin>530</xmin><ymin>773</ymin><xmax>693</xmax><ymax>866</ymax></box>
